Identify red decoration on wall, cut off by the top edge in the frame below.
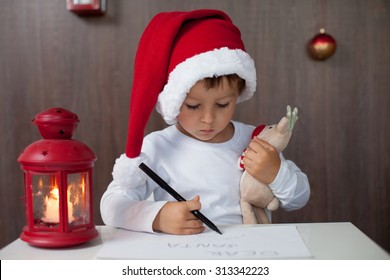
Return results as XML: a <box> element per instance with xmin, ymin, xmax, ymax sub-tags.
<box><xmin>66</xmin><ymin>0</ymin><xmax>106</xmax><ymax>16</ymax></box>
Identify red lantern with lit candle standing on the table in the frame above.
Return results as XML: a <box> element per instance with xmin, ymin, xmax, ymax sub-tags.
<box><xmin>18</xmin><ymin>108</ymin><xmax>98</xmax><ymax>247</ymax></box>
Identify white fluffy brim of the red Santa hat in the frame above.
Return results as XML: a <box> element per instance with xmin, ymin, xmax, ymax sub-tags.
<box><xmin>156</xmin><ymin>47</ymin><xmax>256</xmax><ymax>124</ymax></box>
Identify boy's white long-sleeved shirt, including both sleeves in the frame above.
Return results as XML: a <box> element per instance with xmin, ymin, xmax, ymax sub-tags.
<box><xmin>100</xmin><ymin>122</ymin><xmax>310</xmax><ymax>232</ymax></box>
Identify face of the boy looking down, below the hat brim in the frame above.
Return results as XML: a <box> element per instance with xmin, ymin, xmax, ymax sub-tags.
<box><xmin>177</xmin><ymin>78</ymin><xmax>239</xmax><ymax>143</ymax></box>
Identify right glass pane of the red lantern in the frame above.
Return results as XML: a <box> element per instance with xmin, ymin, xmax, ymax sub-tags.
<box><xmin>67</xmin><ymin>172</ymin><xmax>90</xmax><ymax>226</ymax></box>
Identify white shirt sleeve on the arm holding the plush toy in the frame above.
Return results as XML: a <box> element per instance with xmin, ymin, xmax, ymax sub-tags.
<box><xmin>269</xmin><ymin>154</ymin><xmax>310</xmax><ymax>211</ymax></box>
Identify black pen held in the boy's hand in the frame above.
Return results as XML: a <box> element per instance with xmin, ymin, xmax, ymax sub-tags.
<box><xmin>139</xmin><ymin>163</ymin><xmax>222</xmax><ymax>234</ymax></box>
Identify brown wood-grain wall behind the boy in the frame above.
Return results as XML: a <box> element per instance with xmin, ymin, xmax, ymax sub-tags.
<box><xmin>0</xmin><ymin>0</ymin><xmax>390</xmax><ymax>251</ymax></box>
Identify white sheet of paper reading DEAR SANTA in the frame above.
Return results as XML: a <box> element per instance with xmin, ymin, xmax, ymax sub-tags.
<box><xmin>96</xmin><ymin>225</ymin><xmax>311</xmax><ymax>260</ymax></box>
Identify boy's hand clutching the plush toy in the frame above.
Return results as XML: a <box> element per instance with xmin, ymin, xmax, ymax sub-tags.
<box><xmin>244</xmin><ymin>137</ymin><xmax>281</xmax><ymax>184</ymax></box>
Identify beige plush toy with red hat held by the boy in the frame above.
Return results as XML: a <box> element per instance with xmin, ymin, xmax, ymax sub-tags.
<box><xmin>239</xmin><ymin>106</ymin><xmax>298</xmax><ymax>224</ymax></box>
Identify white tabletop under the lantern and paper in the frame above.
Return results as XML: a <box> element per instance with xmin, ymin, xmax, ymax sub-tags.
<box><xmin>0</xmin><ymin>222</ymin><xmax>390</xmax><ymax>260</ymax></box>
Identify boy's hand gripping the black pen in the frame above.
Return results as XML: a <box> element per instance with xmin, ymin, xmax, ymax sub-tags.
<box><xmin>153</xmin><ymin>196</ymin><xmax>205</xmax><ymax>234</ymax></box>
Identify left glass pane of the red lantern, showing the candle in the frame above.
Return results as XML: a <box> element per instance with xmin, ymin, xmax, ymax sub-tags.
<box><xmin>32</xmin><ymin>174</ymin><xmax>60</xmax><ymax>228</ymax></box>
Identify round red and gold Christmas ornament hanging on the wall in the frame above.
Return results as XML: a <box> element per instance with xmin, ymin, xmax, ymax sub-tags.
<box><xmin>308</xmin><ymin>28</ymin><xmax>336</xmax><ymax>60</ymax></box>
